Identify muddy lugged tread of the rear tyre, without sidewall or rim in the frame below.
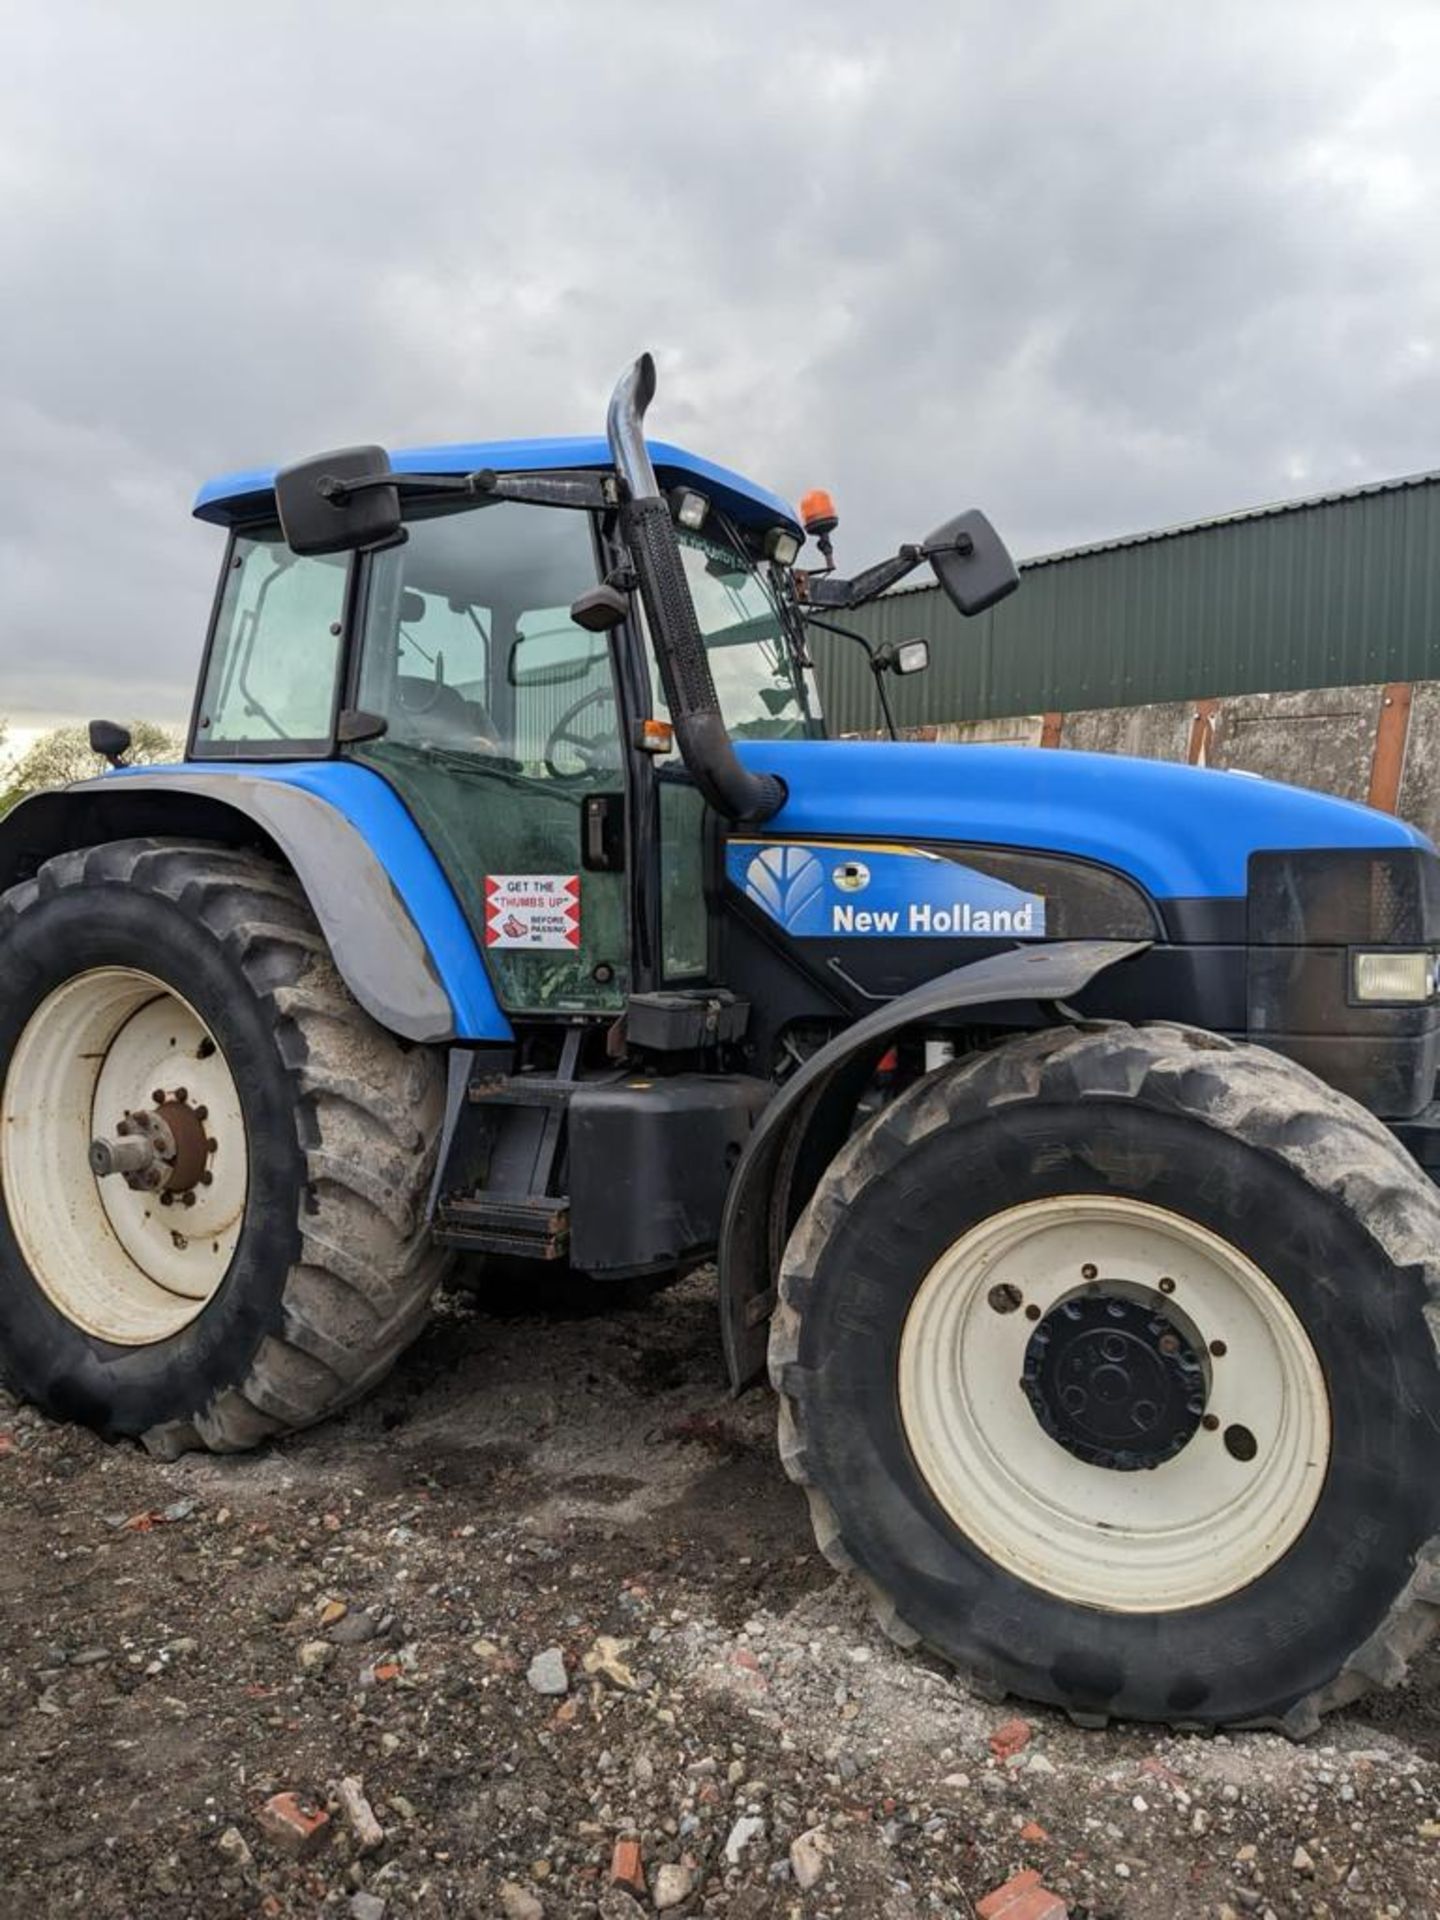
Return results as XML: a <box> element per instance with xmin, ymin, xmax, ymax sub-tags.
<box><xmin>0</xmin><ymin>839</ymin><xmax>449</xmax><ymax>1459</ymax></box>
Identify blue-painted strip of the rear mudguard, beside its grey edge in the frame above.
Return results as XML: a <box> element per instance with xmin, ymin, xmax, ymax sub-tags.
<box><xmin>108</xmin><ymin>760</ymin><xmax>511</xmax><ymax>1041</ymax></box>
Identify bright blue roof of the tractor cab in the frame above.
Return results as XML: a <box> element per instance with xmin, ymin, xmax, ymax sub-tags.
<box><xmin>194</xmin><ymin>434</ymin><xmax>801</xmax><ymax>534</ymax></box>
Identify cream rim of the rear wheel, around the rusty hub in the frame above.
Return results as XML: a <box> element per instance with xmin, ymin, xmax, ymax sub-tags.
<box><xmin>0</xmin><ymin>968</ymin><xmax>250</xmax><ymax>1346</ymax></box>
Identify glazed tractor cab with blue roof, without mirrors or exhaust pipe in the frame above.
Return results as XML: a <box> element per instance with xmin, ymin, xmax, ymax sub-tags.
<box><xmin>188</xmin><ymin>440</ymin><xmax>822</xmax><ymax>1014</ymax></box>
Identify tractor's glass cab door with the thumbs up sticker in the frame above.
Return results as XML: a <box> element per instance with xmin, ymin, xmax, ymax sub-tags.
<box><xmin>348</xmin><ymin>501</ymin><xmax>630</xmax><ymax>1014</ymax></box>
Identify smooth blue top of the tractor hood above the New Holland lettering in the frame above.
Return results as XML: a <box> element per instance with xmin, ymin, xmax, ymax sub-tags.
<box><xmin>737</xmin><ymin>741</ymin><xmax>1430</xmax><ymax>899</ymax></box>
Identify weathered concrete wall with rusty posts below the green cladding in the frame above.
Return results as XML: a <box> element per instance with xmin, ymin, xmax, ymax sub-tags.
<box><xmin>867</xmin><ymin>680</ymin><xmax>1440</xmax><ymax>841</ymax></box>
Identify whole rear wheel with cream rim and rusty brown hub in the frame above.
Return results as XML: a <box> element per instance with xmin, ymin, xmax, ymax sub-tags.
<box><xmin>0</xmin><ymin>841</ymin><xmax>445</xmax><ymax>1455</ymax></box>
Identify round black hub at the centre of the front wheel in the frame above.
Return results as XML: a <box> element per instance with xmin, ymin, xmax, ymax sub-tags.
<box><xmin>1020</xmin><ymin>1286</ymin><xmax>1208</xmax><ymax>1473</ymax></box>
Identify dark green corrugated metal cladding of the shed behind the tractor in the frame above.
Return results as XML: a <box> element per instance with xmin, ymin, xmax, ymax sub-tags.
<box><xmin>812</xmin><ymin>472</ymin><xmax>1440</xmax><ymax>733</ymax></box>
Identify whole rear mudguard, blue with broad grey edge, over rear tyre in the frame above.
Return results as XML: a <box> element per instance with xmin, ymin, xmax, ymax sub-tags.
<box><xmin>0</xmin><ymin>760</ymin><xmax>511</xmax><ymax>1043</ymax></box>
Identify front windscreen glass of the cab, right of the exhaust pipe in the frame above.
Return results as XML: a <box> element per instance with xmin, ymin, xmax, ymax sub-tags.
<box><xmin>655</xmin><ymin>528</ymin><xmax>820</xmax><ymax>739</ymax></box>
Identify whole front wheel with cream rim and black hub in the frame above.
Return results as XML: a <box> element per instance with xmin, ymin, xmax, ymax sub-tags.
<box><xmin>770</xmin><ymin>1025</ymin><xmax>1440</xmax><ymax>1736</ymax></box>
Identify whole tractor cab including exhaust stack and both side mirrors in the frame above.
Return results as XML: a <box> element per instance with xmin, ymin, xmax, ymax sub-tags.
<box><xmin>190</xmin><ymin>359</ymin><xmax>1016</xmax><ymax>1018</ymax></box>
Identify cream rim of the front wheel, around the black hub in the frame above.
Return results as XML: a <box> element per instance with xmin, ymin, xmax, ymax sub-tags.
<box><xmin>899</xmin><ymin>1194</ymin><xmax>1331</xmax><ymax>1613</ymax></box>
